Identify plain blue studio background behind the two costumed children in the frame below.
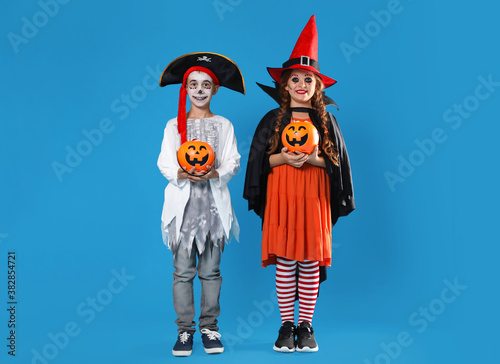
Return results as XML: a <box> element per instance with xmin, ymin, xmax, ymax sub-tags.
<box><xmin>0</xmin><ymin>0</ymin><xmax>500</xmax><ymax>364</ymax></box>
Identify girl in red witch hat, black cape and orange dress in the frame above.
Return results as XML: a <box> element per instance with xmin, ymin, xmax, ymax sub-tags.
<box><xmin>244</xmin><ymin>16</ymin><xmax>354</xmax><ymax>352</ymax></box>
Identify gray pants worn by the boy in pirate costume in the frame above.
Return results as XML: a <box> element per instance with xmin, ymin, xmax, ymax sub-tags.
<box><xmin>172</xmin><ymin>239</ymin><xmax>222</xmax><ymax>334</ymax></box>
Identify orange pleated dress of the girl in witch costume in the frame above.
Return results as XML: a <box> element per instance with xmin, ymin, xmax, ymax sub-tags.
<box><xmin>262</xmin><ymin>128</ymin><xmax>332</xmax><ymax>267</ymax></box>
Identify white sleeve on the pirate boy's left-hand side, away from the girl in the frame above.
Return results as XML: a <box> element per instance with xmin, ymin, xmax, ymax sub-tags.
<box><xmin>158</xmin><ymin>120</ymin><xmax>188</xmax><ymax>187</ymax></box>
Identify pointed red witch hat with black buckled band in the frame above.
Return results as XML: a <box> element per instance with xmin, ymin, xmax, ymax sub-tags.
<box><xmin>267</xmin><ymin>15</ymin><xmax>337</xmax><ymax>88</ymax></box>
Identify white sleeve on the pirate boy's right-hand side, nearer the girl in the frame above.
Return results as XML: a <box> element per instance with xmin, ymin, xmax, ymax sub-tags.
<box><xmin>213</xmin><ymin>121</ymin><xmax>241</xmax><ymax>188</ymax></box>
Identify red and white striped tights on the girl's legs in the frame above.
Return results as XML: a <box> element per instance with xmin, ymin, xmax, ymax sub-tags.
<box><xmin>276</xmin><ymin>257</ymin><xmax>319</xmax><ymax>324</ymax></box>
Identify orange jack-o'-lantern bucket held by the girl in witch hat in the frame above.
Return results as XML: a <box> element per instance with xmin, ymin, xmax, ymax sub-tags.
<box><xmin>281</xmin><ymin>121</ymin><xmax>319</xmax><ymax>154</ymax></box>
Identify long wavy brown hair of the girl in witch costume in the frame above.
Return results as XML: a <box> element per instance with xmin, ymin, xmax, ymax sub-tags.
<box><xmin>267</xmin><ymin>69</ymin><xmax>339</xmax><ymax>166</ymax></box>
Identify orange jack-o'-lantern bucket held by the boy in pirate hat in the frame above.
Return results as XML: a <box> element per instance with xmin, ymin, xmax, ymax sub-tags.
<box><xmin>177</xmin><ymin>140</ymin><xmax>215</xmax><ymax>172</ymax></box>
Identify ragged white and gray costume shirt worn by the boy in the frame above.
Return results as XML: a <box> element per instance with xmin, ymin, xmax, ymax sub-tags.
<box><xmin>158</xmin><ymin>115</ymin><xmax>240</xmax><ymax>254</ymax></box>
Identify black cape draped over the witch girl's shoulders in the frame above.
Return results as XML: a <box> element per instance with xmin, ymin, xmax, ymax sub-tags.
<box><xmin>243</xmin><ymin>109</ymin><xmax>355</xmax><ymax>281</ymax></box>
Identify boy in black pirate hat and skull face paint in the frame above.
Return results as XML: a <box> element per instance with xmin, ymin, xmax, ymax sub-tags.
<box><xmin>158</xmin><ymin>52</ymin><xmax>245</xmax><ymax>356</ymax></box>
